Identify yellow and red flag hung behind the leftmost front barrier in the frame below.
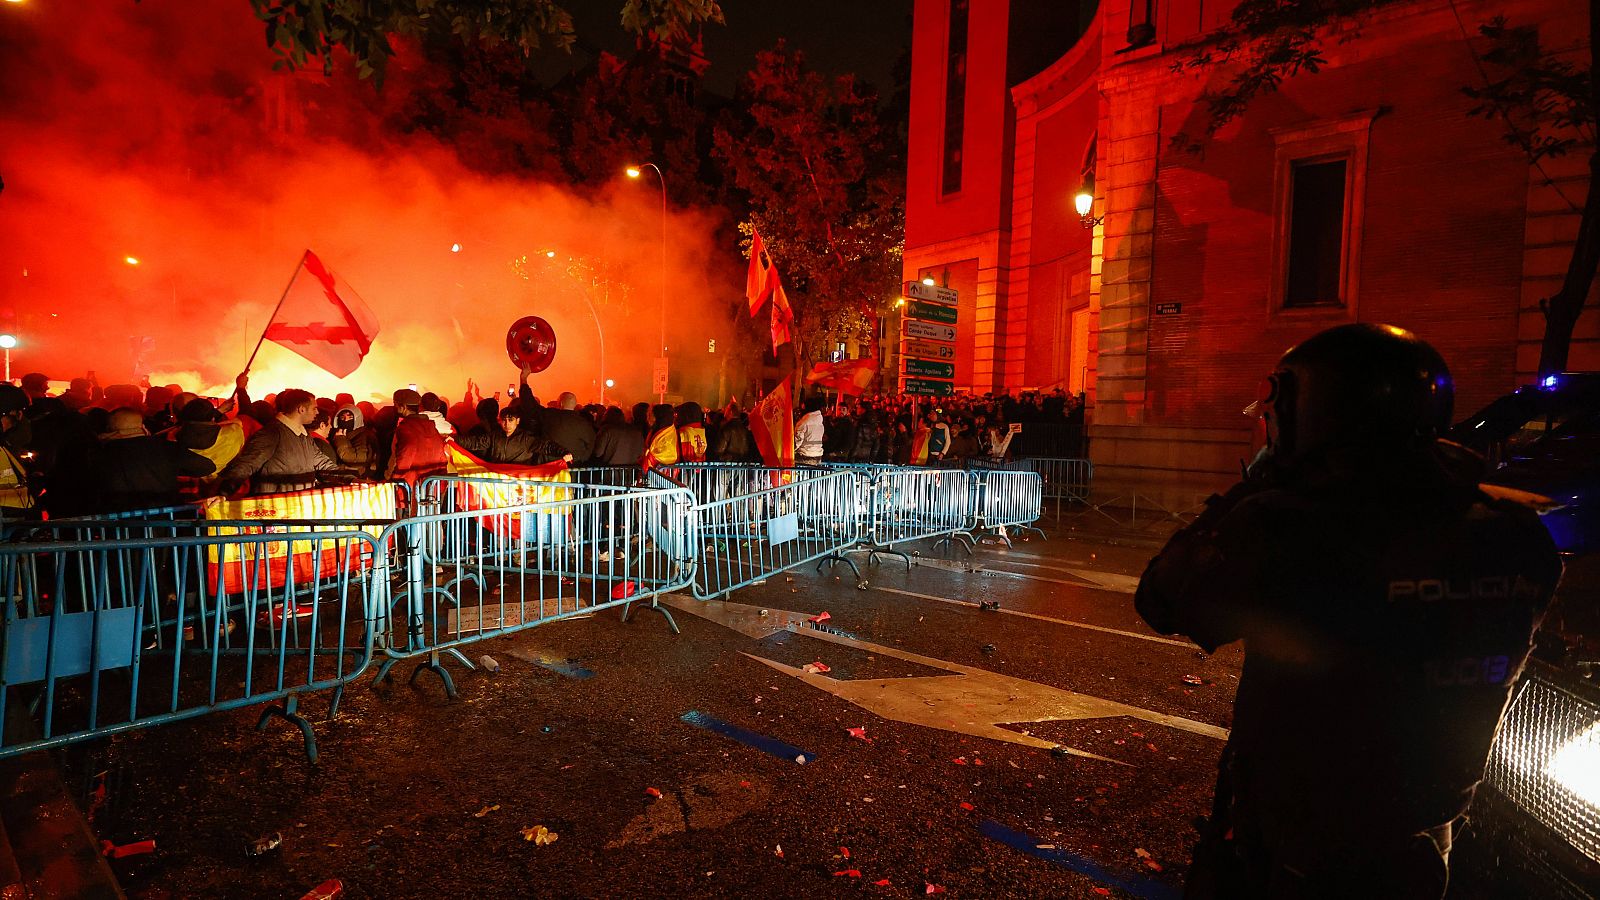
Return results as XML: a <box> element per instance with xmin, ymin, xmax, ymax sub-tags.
<box><xmin>202</xmin><ymin>484</ymin><xmax>395</xmax><ymax>594</ymax></box>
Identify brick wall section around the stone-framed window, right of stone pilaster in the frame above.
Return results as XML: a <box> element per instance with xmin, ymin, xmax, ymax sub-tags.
<box><xmin>1147</xmin><ymin>16</ymin><xmax>1528</xmax><ymax>426</ymax></box>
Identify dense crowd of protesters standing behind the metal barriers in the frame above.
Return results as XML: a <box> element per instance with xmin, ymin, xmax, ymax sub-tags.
<box><xmin>0</xmin><ymin>365</ymin><xmax>1083</xmax><ymax>517</ymax></box>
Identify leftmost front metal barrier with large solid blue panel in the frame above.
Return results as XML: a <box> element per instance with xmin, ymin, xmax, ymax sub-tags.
<box><xmin>0</xmin><ymin>519</ymin><xmax>387</xmax><ymax>761</ymax></box>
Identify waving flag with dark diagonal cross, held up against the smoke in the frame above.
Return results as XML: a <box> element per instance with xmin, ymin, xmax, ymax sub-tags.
<box><xmin>264</xmin><ymin>250</ymin><xmax>378</xmax><ymax>378</ymax></box>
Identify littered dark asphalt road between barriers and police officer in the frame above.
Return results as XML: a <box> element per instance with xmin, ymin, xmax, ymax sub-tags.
<box><xmin>70</xmin><ymin>525</ymin><xmax>1580</xmax><ymax>898</ymax></box>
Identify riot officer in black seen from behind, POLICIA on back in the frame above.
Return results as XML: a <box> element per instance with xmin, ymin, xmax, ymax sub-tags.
<box><xmin>1136</xmin><ymin>325</ymin><xmax>1562</xmax><ymax>900</ymax></box>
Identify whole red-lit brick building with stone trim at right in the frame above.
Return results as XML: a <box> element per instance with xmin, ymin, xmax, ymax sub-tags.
<box><xmin>906</xmin><ymin>0</ymin><xmax>1600</xmax><ymax>503</ymax></box>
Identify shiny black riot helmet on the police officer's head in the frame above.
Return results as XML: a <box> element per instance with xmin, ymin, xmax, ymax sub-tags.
<box><xmin>1245</xmin><ymin>323</ymin><xmax>1456</xmax><ymax>460</ymax></box>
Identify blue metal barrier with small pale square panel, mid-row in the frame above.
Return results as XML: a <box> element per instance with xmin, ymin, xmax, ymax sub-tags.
<box><xmin>650</xmin><ymin>463</ymin><xmax>867</xmax><ymax>599</ymax></box>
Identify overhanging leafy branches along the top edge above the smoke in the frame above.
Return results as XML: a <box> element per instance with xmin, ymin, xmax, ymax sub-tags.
<box><xmin>250</xmin><ymin>0</ymin><xmax>723</xmax><ymax>83</ymax></box>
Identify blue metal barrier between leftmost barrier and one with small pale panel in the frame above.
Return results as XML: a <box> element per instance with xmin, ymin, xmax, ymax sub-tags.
<box><xmin>378</xmin><ymin>477</ymin><xmax>694</xmax><ymax>697</ymax></box>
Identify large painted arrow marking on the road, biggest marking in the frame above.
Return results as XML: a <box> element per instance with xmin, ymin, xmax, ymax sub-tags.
<box><xmin>662</xmin><ymin>594</ymin><xmax>1227</xmax><ymax>755</ymax></box>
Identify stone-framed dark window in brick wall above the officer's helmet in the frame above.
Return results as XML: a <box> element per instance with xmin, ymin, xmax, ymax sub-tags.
<box><xmin>1269</xmin><ymin>112</ymin><xmax>1373</xmax><ymax>319</ymax></box>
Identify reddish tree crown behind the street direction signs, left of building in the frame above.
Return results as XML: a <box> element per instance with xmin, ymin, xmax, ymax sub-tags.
<box><xmin>714</xmin><ymin>43</ymin><xmax>904</xmax><ymax>362</ymax></box>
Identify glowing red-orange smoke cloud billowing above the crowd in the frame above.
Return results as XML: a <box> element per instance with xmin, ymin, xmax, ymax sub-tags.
<box><xmin>0</xmin><ymin>0</ymin><xmax>742</xmax><ymax>402</ymax></box>
